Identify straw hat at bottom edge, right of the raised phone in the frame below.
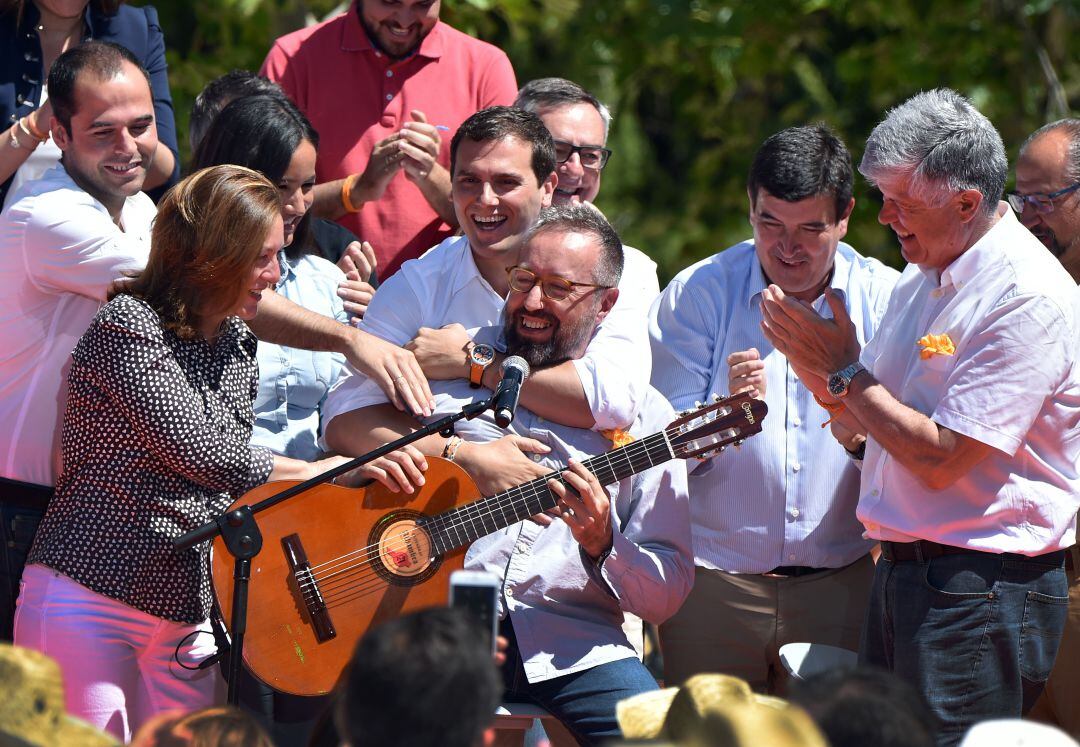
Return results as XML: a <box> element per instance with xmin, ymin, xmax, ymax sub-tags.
<box><xmin>616</xmin><ymin>675</ymin><xmax>826</xmax><ymax>747</ymax></box>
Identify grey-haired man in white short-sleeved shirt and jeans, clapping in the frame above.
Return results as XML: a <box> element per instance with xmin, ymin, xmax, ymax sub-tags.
<box><xmin>762</xmin><ymin>90</ymin><xmax>1080</xmax><ymax>745</ymax></box>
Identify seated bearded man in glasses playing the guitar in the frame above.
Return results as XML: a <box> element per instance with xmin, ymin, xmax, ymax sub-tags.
<box><xmin>328</xmin><ymin>205</ymin><xmax>699</xmax><ymax>744</ymax></box>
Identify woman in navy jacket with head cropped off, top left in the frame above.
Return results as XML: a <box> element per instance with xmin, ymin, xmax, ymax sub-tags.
<box><xmin>0</xmin><ymin>0</ymin><xmax>179</xmax><ymax>206</ymax></box>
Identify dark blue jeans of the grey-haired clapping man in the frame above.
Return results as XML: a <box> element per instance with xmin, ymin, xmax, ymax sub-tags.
<box><xmin>860</xmin><ymin>553</ymin><xmax>1068</xmax><ymax>745</ymax></box>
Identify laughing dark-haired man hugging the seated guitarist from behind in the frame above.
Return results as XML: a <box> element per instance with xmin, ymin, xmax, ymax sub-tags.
<box><xmin>323</xmin><ymin>107</ymin><xmax>647</xmax><ymax>491</ymax></box>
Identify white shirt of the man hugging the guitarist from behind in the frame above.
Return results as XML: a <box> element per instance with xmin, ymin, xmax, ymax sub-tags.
<box><xmin>323</xmin><ymin>236</ymin><xmax>658</xmax><ymax>430</ymax></box>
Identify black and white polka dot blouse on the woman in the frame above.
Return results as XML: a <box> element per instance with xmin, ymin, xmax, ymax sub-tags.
<box><xmin>28</xmin><ymin>296</ymin><xmax>273</xmax><ymax>623</ymax></box>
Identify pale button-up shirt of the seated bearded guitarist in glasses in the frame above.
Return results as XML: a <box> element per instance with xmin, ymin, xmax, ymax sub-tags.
<box><xmin>416</xmin><ymin>338</ymin><xmax>693</xmax><ymax>682</ymax></box>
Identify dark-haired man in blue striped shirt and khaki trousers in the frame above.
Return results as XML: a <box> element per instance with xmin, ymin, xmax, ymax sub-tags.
<box><xmin>649</xmin><ymin>125</ymin><xmax>899</xmax><ymax>693</ymax></box>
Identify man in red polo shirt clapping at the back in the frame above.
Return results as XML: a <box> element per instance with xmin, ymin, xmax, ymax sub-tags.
<box><xmin>261</xmin><ymin>0</ymin><xmax>517</xmax><ymax>279</ymax></box>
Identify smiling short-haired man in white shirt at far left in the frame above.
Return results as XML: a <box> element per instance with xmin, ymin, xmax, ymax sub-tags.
<box><xmin>0</xmin><ymin>42</ymin><xmax>158</xmax><ymax>637</ymax></box>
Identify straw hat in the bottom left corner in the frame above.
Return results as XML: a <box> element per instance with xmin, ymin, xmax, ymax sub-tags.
<box><xmin>0</xmin><ymin>643</ymin><xmax>117</xmax><ymax>747</ymax></box>
